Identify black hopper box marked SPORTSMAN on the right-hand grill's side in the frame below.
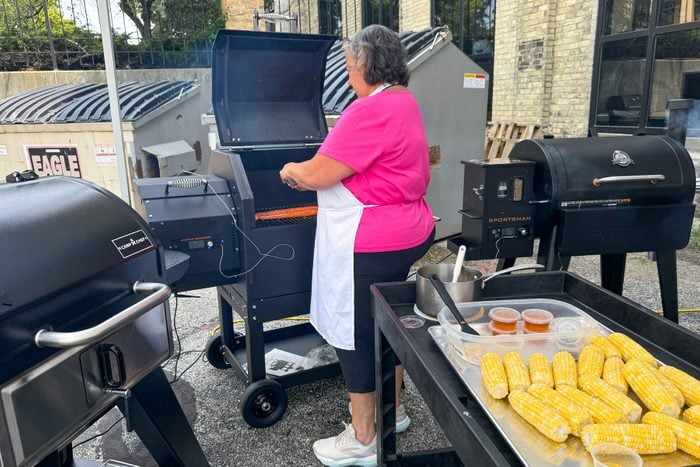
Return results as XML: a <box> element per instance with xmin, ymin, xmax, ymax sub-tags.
<box><xmin>458</xmin><ymin>159</ymin><xmax>535</xmax><ymax>259</ymax></box>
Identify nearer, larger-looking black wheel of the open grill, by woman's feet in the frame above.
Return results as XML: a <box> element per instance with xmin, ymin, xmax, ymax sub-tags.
<box><xmin>241</xmin><ymin>379</ymin><xmax>287</xmax><ymax>428</ymax></box>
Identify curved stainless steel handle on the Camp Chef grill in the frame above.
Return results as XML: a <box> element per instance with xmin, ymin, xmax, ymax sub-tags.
<box><xmin>34</xmin><ymin>282</ymin><xmax>171</xmax><ymax>348</ymax></box>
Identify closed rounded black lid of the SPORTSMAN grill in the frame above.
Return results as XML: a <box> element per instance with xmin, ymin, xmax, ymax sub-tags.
<box><xmin>509</xmin><ymin>136</ymin><xmax>695</xmax><ymax>209</ymax></box>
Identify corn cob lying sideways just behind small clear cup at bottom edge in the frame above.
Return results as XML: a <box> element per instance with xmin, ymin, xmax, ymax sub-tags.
<box><xmin>581</xmin><ymin>423</ymin><xmax>676</xmax><ymax>454</ymax></box>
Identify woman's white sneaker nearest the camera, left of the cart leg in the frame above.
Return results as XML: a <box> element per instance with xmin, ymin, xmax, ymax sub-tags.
<box><xmin>314</xmin><ymin>423</ymin><xmax>377</xmax><ymax>467</ymax></box>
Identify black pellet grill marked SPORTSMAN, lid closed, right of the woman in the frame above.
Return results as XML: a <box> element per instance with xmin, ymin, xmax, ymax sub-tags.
<box><xmin>449</xmin><ymin>136</ymin><xmax>695</xmax><ymax>322</ymax></box>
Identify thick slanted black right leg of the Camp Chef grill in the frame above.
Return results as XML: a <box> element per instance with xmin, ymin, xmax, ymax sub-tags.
<box><xmin>118</xmin><ymin>368</ymin><xmax>209</xmax><ymax>467</ymax></box>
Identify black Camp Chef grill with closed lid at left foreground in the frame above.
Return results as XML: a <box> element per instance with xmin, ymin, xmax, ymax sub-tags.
<box><xmin>0</xmin><ymin>177</ymin><xmax>207</xmax><ymax>467</ymax></box>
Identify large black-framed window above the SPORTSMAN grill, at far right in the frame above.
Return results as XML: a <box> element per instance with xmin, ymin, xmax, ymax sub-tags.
<box><xmin>590</xmin><ymin>0</ymin><xmax>700</xmax><ymax>134</ymax></box>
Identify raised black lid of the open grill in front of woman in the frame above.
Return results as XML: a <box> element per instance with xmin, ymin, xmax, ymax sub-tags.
<box><xmin>212</xmin><ymin>30</ymin><xmax>337</xmax><ymax>148</ymax></box>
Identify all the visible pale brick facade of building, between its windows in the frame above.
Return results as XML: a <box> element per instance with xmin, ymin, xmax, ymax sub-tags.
<box><xmin>223</xmin><ymin>0</ymin><xmax>598</xmax><ymax>137</ymax></box>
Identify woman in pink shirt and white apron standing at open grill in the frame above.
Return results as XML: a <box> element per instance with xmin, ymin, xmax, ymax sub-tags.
<box><xmin>280</xmin><ymin>25</ymin><xmax>435</xmax><ymax>465</ymax></box>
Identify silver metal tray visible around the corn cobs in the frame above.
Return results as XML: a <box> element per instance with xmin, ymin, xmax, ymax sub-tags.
<box><xmin>428</xmin><ymin>326</ymin><xmax>700</xmax><ymax>467</ymax></box>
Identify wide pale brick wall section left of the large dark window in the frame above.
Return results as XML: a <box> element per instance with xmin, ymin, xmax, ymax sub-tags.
<box><xmin>492</xmin><ymin>0</ymin><xmax>597</xmax><ymax>137</ymax></box>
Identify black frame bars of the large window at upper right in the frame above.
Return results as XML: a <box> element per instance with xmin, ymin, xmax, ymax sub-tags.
<box><xmin>588</xmin><ymin>0</ymin><xmax>700</xmax><ymax>135</ymax></box>
